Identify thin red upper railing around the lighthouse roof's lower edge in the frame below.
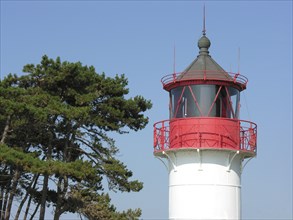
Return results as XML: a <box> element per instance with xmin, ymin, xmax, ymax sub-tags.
<box><xmin>161</xmin><ymin>70</ymin><xmax>248</xmax><ymax>87</ymax></box>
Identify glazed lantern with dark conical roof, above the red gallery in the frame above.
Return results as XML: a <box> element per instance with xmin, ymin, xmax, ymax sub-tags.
<box><xmin>162</xmin><ymin>35</ymin><xmax>247</xmax><ymax>119</ymax></box>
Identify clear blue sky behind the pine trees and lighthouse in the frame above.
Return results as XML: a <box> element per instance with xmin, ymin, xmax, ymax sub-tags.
<box><xmin>0</xmin><ymin>0</ymin><xmax>292</xmax><ymax>219</ymax></box>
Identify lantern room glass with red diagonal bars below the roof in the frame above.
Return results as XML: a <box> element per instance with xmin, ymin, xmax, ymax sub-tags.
<box><xmin>170</xmin><ymin>85</ymin><xmax>239</xmax><ymax>119</ymax></box>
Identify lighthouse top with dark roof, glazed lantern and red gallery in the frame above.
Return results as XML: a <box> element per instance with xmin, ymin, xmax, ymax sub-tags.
<box><xmin>154</xmin><ymin>32</ymin><xmax>257</xmax><ymax>157</ymax></box>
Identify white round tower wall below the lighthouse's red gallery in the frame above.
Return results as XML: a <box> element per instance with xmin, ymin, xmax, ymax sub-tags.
<box><xmin>165</xmin><ymin>149</ymin><xmax>242</xmax><ymax>220</ymax></box>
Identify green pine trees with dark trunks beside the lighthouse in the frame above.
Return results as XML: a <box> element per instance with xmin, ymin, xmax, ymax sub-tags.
<box><xmin>0</xmin><ymin>56</ymin><xmax>151</xmax><ymax>220</ymax></box>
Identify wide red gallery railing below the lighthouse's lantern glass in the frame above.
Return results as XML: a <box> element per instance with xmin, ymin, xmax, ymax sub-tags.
<box><xmin>154</xmin><ymin>117</ymin><xmax>257</xmax><ymax>154</ymax></box>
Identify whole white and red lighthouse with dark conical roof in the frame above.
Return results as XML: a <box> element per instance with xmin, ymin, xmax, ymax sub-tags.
<box><xmin>154</xmin><ymin>12</ymin><xmax>257</xmax><ymax>220</ymax></box>
